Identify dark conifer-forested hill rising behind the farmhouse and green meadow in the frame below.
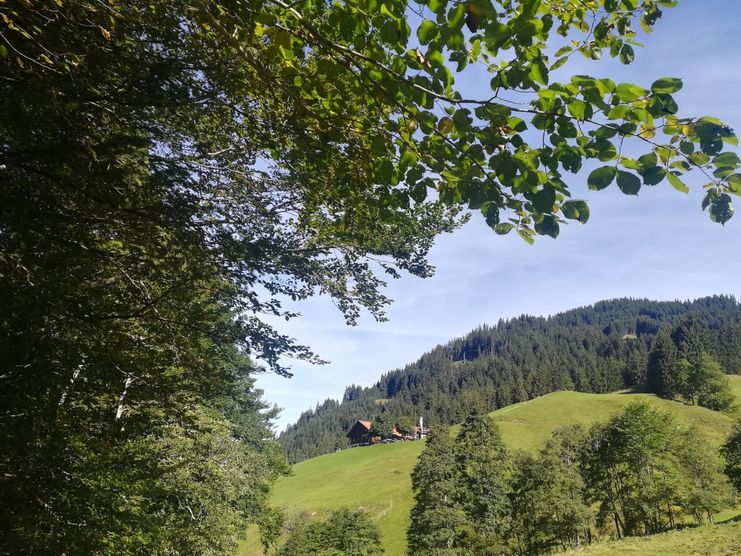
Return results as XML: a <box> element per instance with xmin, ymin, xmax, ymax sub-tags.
<box><xmin>279</xmin><ymin>296</ymin><xmax>741</xmax><ymax>462</ymax></box>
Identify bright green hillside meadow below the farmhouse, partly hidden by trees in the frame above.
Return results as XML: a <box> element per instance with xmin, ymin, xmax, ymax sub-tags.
<box><xmin>239</xmin><ymin>386</ymin><xmax>741</xmax><ymax>556</ymax></box>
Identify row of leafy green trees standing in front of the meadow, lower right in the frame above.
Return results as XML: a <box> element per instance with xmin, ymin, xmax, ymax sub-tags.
<box><xmin>407</xmin><ymin>402</ymin><xmax>739</xmax><ymax>556</ymax></box>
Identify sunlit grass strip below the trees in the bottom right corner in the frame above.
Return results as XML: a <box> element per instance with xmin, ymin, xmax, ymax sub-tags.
<box><xmin>566</xmin><ymin>521</ymin><xmax>741</xmax><ymax>556</ymax></box>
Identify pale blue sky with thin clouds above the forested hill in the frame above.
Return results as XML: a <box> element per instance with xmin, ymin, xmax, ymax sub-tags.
<box><xmin>257</xmin><ymin>0</ymin><xmax>741</xmax><ymax>430</ymax></box>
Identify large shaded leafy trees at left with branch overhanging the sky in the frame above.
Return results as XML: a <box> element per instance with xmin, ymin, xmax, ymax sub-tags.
<box><xmin>0</xmin><ymin>0</ymin><xmax>741</xmax><ymax>554</ymax></box>
